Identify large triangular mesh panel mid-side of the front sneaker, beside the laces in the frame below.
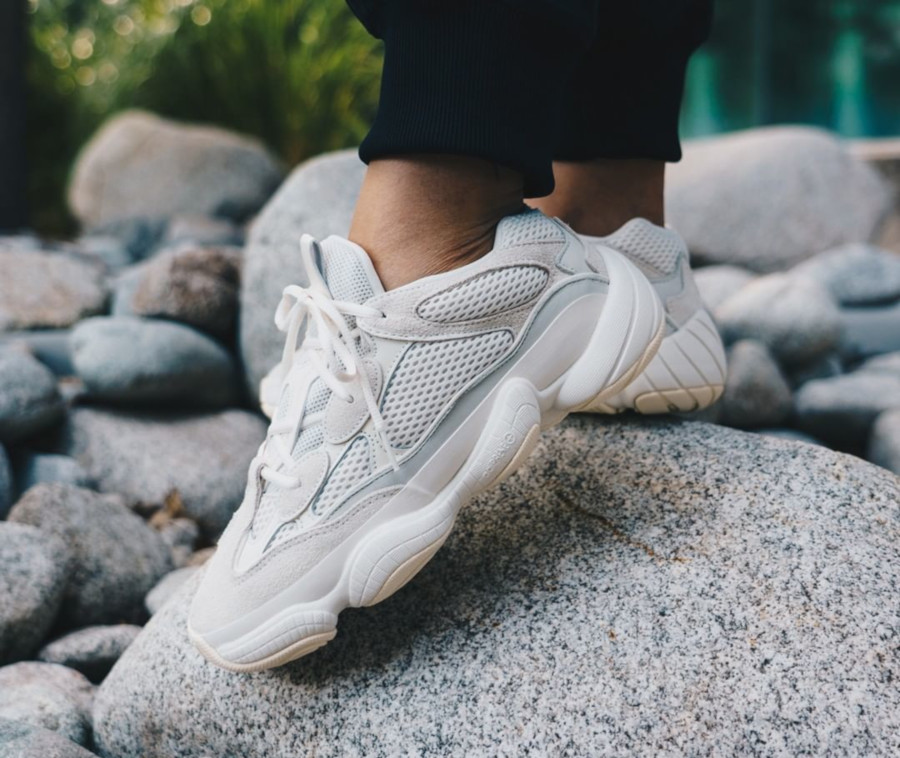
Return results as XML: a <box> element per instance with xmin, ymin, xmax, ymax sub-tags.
<box><xmin>382</xmin><ymin>329</ymin><xmax>513</xmax><ymax>448</ymax></box>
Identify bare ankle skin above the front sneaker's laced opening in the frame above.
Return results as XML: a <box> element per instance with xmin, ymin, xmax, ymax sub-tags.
<box><xmin>350</xmin><ymin>155</ymin><xmax>525</xmax><ymax>289</ymax></box>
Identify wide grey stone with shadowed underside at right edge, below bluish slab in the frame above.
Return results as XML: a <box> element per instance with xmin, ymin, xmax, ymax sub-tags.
<box><xmin>794</xmin><ymin>371</ymin><xmax>900</xmax><ymax>450</ymax></box>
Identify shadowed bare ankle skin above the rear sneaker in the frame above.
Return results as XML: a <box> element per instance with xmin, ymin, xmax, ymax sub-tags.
<box><xmin>528</xmin><ymin>160</ymin><xmax>666</xmax><ymax>237</ymax></box>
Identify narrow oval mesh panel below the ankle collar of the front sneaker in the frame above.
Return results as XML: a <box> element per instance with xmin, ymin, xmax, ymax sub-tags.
<box><xmin>416</xmin><ymin>266</ymin><xmax>549</xmax><ymax>324</ymax></box>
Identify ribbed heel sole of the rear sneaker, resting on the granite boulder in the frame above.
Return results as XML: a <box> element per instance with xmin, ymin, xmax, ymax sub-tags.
<box><xmin>583</xmin><ymin>309</ymin><xmax>726</xmax><ymax>414</ymax></box>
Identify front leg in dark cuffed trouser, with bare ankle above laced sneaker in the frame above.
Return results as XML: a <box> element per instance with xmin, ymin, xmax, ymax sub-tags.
<box><xmin>342</xmin><ymin>0</ymin><xmax>593</xmax><ymax>288</ymax></box>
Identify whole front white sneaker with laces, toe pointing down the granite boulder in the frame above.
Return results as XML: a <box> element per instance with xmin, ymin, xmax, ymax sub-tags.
<box><xmin>188</xmin><ymin>211</ymin><xmax>664</xmax><ymax>671</ymax></box>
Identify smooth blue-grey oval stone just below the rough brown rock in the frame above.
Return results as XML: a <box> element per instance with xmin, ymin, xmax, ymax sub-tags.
<box><xmin>71</xmin><ymin>316</ymin><xmax>238</xmax><ymax>407</ymax></box>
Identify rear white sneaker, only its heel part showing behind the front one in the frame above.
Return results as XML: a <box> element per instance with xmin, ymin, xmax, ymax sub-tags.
<box><xmin>582</xmin><ymin>218</ymin><xmax>726</xmax><ymax>413</ymax></box>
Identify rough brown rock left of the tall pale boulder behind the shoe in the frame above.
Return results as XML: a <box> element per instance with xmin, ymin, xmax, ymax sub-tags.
<box><xmin>132</xmin><ymin>247</ymin><xmax>241</xmax><ymax>341</ymax></box>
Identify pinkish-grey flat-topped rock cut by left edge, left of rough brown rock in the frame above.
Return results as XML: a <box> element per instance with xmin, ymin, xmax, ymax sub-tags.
<box><xmin>0</xmin><ymin>247</ymin><xmax>107</xmax><ymax>332</ymax></box>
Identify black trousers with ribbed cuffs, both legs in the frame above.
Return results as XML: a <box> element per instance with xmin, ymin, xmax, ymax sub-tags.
<box><xmin>348</xmin><ymin>0</ymin><xmax>713</xmax><ymax>197</ymax></box>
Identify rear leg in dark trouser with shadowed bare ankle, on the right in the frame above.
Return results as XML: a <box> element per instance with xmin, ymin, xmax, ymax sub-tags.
<box><xmin>530</xmin><ymin>0</ymin><xmax>713</xmax><ymax>236</ymax></box>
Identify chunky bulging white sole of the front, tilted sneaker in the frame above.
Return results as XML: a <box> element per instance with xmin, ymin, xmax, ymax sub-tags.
<box><xmin>188</xmin><ymin>253</ymin><xmax>665</xmax><ymax>673</ymax></box>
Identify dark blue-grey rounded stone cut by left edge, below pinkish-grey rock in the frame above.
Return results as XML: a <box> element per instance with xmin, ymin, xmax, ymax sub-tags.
<box><xmin>0</xmin><ymin>348</ymin><xmax>64</xmax><ymax>442</ymax></box>
